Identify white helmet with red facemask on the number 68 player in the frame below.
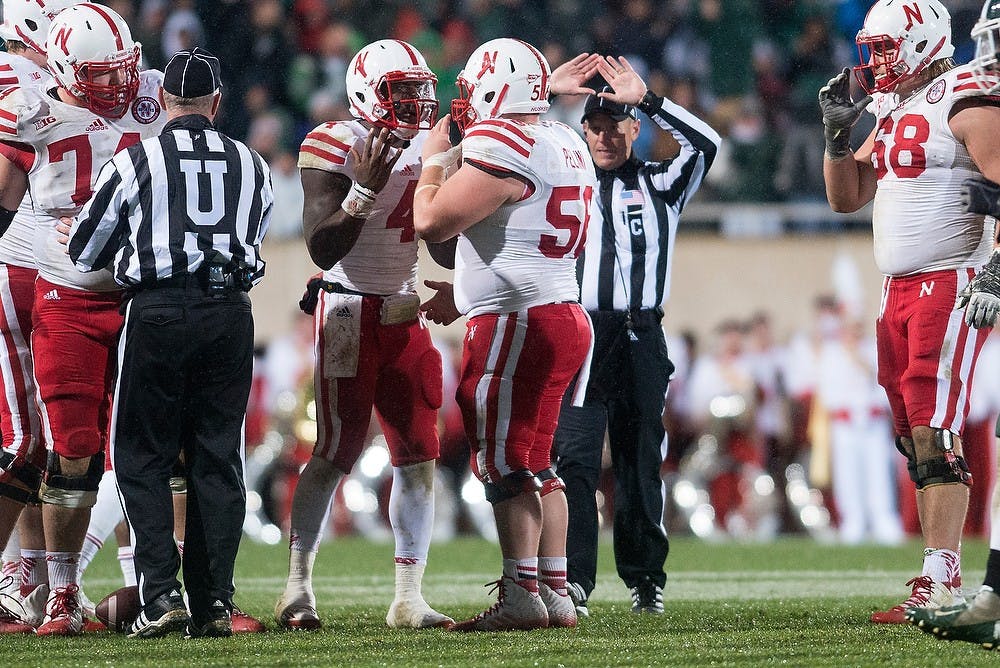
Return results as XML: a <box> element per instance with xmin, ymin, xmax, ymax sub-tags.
<box><xmin>854</xmin><ymin>0</ymin><xmax>955</xmax><ymax>93</ymax></box>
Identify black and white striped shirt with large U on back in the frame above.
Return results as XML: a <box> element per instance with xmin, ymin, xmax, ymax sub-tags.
<box><xmin>69</xmin><ymin>114</ymin><xmax>274</xmax><ymax>287</ymax></box>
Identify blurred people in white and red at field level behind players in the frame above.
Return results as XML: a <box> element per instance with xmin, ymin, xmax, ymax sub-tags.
<box><xmin>247</xmin><ymin>295</ymin><xmax>1000</xmax><ymax>545</ymax></box>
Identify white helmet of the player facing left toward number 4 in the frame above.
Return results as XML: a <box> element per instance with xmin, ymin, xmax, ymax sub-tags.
<box><xmin>451</xmin><ymin>37</ymin><xmax>552</xmax><ymax>132</ymax></box>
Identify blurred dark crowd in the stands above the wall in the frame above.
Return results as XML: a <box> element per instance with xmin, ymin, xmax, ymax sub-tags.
<box><xmin>101</xmin><ymin>0</ymin><xmax>980</xmax><ymax>238</ymax></box>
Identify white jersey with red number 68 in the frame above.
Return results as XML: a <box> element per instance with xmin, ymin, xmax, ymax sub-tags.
<box><xmin>868</xmin><ymin>66</ymin><xmax>994</xmax><ymax>276</ymax></box>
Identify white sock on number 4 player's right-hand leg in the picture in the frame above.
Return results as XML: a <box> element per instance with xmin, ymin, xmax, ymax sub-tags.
<box><xmin>389</xmin><ymin>460</ymin><xmax>434</xmax><ymax>560</ymax></box>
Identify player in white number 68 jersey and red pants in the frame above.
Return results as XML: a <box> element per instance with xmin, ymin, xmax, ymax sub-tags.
<box><xmin>819</xmin><ymin>0</ymin><xmax>1000</xmax><ymax>623</ymax></box>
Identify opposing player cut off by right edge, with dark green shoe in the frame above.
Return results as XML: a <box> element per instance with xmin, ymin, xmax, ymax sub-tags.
<box><xmin>906</xmin><ymin>0</ymin><xmax>1000</xmax><ymax>649</ymax></box>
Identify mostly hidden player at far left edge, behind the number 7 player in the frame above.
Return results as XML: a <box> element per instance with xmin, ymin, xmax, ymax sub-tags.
<box><xmin>0</xmin><ymin>0</ymin><xmax>80</xmax><ymax>634</ymax></box>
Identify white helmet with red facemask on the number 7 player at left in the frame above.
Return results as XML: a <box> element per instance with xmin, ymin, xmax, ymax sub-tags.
<box><xmin>46</xmin><ymin>2</ymin><xmax>141</xmax><ymax>118</ymax></box>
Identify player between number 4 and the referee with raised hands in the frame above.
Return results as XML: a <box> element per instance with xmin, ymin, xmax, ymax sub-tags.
<box><xmin>414</xmin><ymin>38</ymin><xmax>596</xmax><ymax>631</ymax></box>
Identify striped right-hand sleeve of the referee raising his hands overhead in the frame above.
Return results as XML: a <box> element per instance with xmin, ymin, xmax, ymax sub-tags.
<box><xmin>638</xmin><ymin>92</ymin><xmax>722</xmax><ymax>210</ymax></box>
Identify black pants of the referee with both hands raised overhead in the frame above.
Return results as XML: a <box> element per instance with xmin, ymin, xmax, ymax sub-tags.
<box><xmin>555</xmin><ymin>309</ymin><xmax>674</xmax><ymax>596</ymax></box>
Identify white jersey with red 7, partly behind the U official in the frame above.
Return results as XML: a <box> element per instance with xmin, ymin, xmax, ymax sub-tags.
<box><xmin>0</xmin><ymin>70</ymin><xmax>167</xmax><ymax>292</ymax></box>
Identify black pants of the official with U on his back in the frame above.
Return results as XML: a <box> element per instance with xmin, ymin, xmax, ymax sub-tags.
<box><xmin>112</xmin><ymin>287</ymin><xmax>253</xmax><ymax>622</ymax></box>
